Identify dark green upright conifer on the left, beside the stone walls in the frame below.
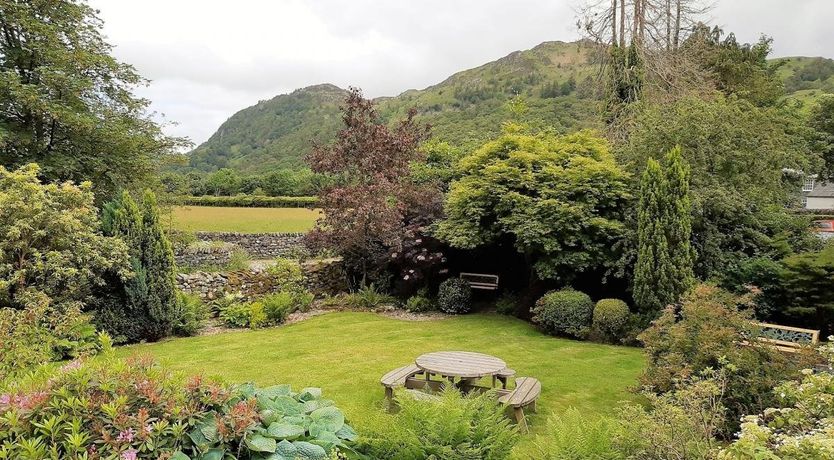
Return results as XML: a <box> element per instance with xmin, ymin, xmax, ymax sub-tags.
<box><xmin>96</xmin><ymin>190</ymin><xmax>177</xmax><ymax>342</ymax></box>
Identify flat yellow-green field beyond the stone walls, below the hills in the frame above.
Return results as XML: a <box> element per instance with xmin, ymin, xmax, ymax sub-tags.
<box><xmin>171</xmin><ymin>206</ymin><xmax>319</xmax><ymax>233</ymax></box>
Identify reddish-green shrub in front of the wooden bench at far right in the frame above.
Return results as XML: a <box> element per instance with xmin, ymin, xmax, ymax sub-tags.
<box><xmin>639</xmin><ymin>285</ymin><xmax>815</xmax><ymax>436</ymax></box>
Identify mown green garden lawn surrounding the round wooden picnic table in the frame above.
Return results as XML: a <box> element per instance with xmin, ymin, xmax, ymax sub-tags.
<box><xmin>119</xmin><ymin>313</ymin><xmax>644</xmax><ymax>458</ymax></box>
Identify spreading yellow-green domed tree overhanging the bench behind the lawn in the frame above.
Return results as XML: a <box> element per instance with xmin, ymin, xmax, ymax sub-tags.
<box><xmin>437</xmin><ymin>129</ymin><xmax>630</xmax><ymax>279</ymax></box>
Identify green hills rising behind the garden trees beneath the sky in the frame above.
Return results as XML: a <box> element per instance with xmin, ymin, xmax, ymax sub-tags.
<box><xmin>185</xmin><ymin>42</ymin><xmax>834</xmax><ymax>174</ymax></box>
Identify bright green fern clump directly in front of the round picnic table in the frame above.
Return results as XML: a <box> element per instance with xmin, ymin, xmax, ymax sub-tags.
<box><xmin>357</xmin><ymin>389</ymin><xmax>519</xmax><ymax>460</ymax></box>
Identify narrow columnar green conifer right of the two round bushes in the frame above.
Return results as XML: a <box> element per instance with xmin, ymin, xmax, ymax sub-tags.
<box><xmin>634</xmin><ymin>147</ymin><xmax>695</xmax><ymax>314</ymax></box>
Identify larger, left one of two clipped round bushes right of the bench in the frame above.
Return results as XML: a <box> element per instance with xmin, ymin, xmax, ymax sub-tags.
<box><xmin>532</xmin><ymin>288</ymin><xmax>594</xmax><ymax>338</ymax></box>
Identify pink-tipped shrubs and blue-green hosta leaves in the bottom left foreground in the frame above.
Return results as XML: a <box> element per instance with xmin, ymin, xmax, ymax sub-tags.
<box><xmin>0</xmin><ymin>356</ymin><xmax>357</xmax><ymax>460</ymax></box>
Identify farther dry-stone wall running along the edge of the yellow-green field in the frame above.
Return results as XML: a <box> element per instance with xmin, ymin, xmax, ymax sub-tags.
<box><xmin>196</xmin><ymin>232</ymin><xmax>306</xmax><ymax>259</ymax></box>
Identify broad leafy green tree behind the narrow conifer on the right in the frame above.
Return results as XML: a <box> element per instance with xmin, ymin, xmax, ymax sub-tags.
<box><xmin>617</xmin><ymin>97</ymin><xmax>819</xmax><ymax>279</ymax></box>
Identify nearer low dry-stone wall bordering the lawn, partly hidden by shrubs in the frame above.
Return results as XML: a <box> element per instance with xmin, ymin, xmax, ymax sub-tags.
<box><xmin>177</xmin><ymin>258</ymin><xmax>347</xmax><ymax>300</ymax></box>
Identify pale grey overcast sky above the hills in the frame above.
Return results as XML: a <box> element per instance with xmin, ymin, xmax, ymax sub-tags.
<box><xmin>90</xmin><ymin>0</ymin><xmax>834</xmax><ymax>144</ymax></box>
